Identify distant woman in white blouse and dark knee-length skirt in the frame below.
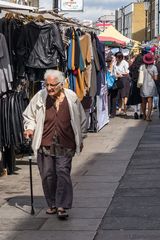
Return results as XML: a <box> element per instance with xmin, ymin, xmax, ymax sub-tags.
<box><xmin>114</xmin><ymin>52</ymin><xmax>130</xmax><ymax>115</ymax></box>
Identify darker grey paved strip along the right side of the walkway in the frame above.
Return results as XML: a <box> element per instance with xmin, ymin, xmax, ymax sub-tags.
<box><xmin>95</xmin><ymin>113</ymin><xmax>160</xmax><ymax>240</ymax></box>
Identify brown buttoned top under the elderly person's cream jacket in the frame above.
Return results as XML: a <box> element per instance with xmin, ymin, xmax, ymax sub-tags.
<box><xmin>41</xmin><ymin>96</ymin><xmax>76</xmax><ymax>149</ymax></box>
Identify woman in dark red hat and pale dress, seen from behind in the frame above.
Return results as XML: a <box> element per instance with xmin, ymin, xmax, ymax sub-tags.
<box><xmin>140</xmin><ymin>53</ymin><xmax>158</xmax><ymax>121</ymax></box>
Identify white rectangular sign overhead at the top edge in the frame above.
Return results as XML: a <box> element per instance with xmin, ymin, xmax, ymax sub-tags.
<box><xmin>60</xmin><ymin>0</ymin><xmax>84</xmax><ymax>11</ymax></box>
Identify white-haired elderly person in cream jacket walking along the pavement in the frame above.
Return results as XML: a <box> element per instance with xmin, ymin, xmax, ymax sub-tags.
<box><xmin>23</xmin><ymin>70</ymin><xmax>86</xmax><ymax>219</ymax></box>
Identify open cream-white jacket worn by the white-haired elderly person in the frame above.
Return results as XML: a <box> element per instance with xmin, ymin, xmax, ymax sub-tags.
<box><xmin>23</xmin><ymin>89</ymin><xmax>86</xmax><ymax>156</ymax></box>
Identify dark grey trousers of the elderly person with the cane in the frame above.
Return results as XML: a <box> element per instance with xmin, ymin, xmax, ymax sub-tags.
<box><xmin>37</xmin><ymin>152</ymin><xmax>73</xmax><ymax>209</ymax></box>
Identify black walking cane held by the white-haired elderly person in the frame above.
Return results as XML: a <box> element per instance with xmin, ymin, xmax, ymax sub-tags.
<box><xmin>28</xmin><ymin>138</ymin><xmax>35</xmax><ymax>215</ymax></box>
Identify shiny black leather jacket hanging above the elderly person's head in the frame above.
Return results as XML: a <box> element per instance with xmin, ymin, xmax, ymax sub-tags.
<box><xmin>17</xmin><ymin>22</ymin><xmax>66</xmax><ymax>69</ymax></box>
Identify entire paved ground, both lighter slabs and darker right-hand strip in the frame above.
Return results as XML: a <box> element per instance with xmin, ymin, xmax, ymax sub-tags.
<box><xmin>0</xmin><ymin>112</ymin><xmax>160</xmax><ymax>240</ymax></box>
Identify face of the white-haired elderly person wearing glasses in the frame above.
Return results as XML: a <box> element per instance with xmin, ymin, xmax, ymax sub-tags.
<box><xmin>45</xmin><ymin>76</ymin><xmax>63</xmax><ymax>96</ymax></box>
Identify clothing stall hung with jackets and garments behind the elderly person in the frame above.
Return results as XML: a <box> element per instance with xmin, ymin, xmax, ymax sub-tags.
<box><xmin>0</xmin><ymin>5</ymin><xmax>109</xmax><ymax>174</ymax></box>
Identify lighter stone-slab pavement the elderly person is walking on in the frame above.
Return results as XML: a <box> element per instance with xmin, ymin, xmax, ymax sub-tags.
<box><xmin>0</xmin><ymin>113</ymin><xmax>148</xmax><ymax>240</ymax></box>
